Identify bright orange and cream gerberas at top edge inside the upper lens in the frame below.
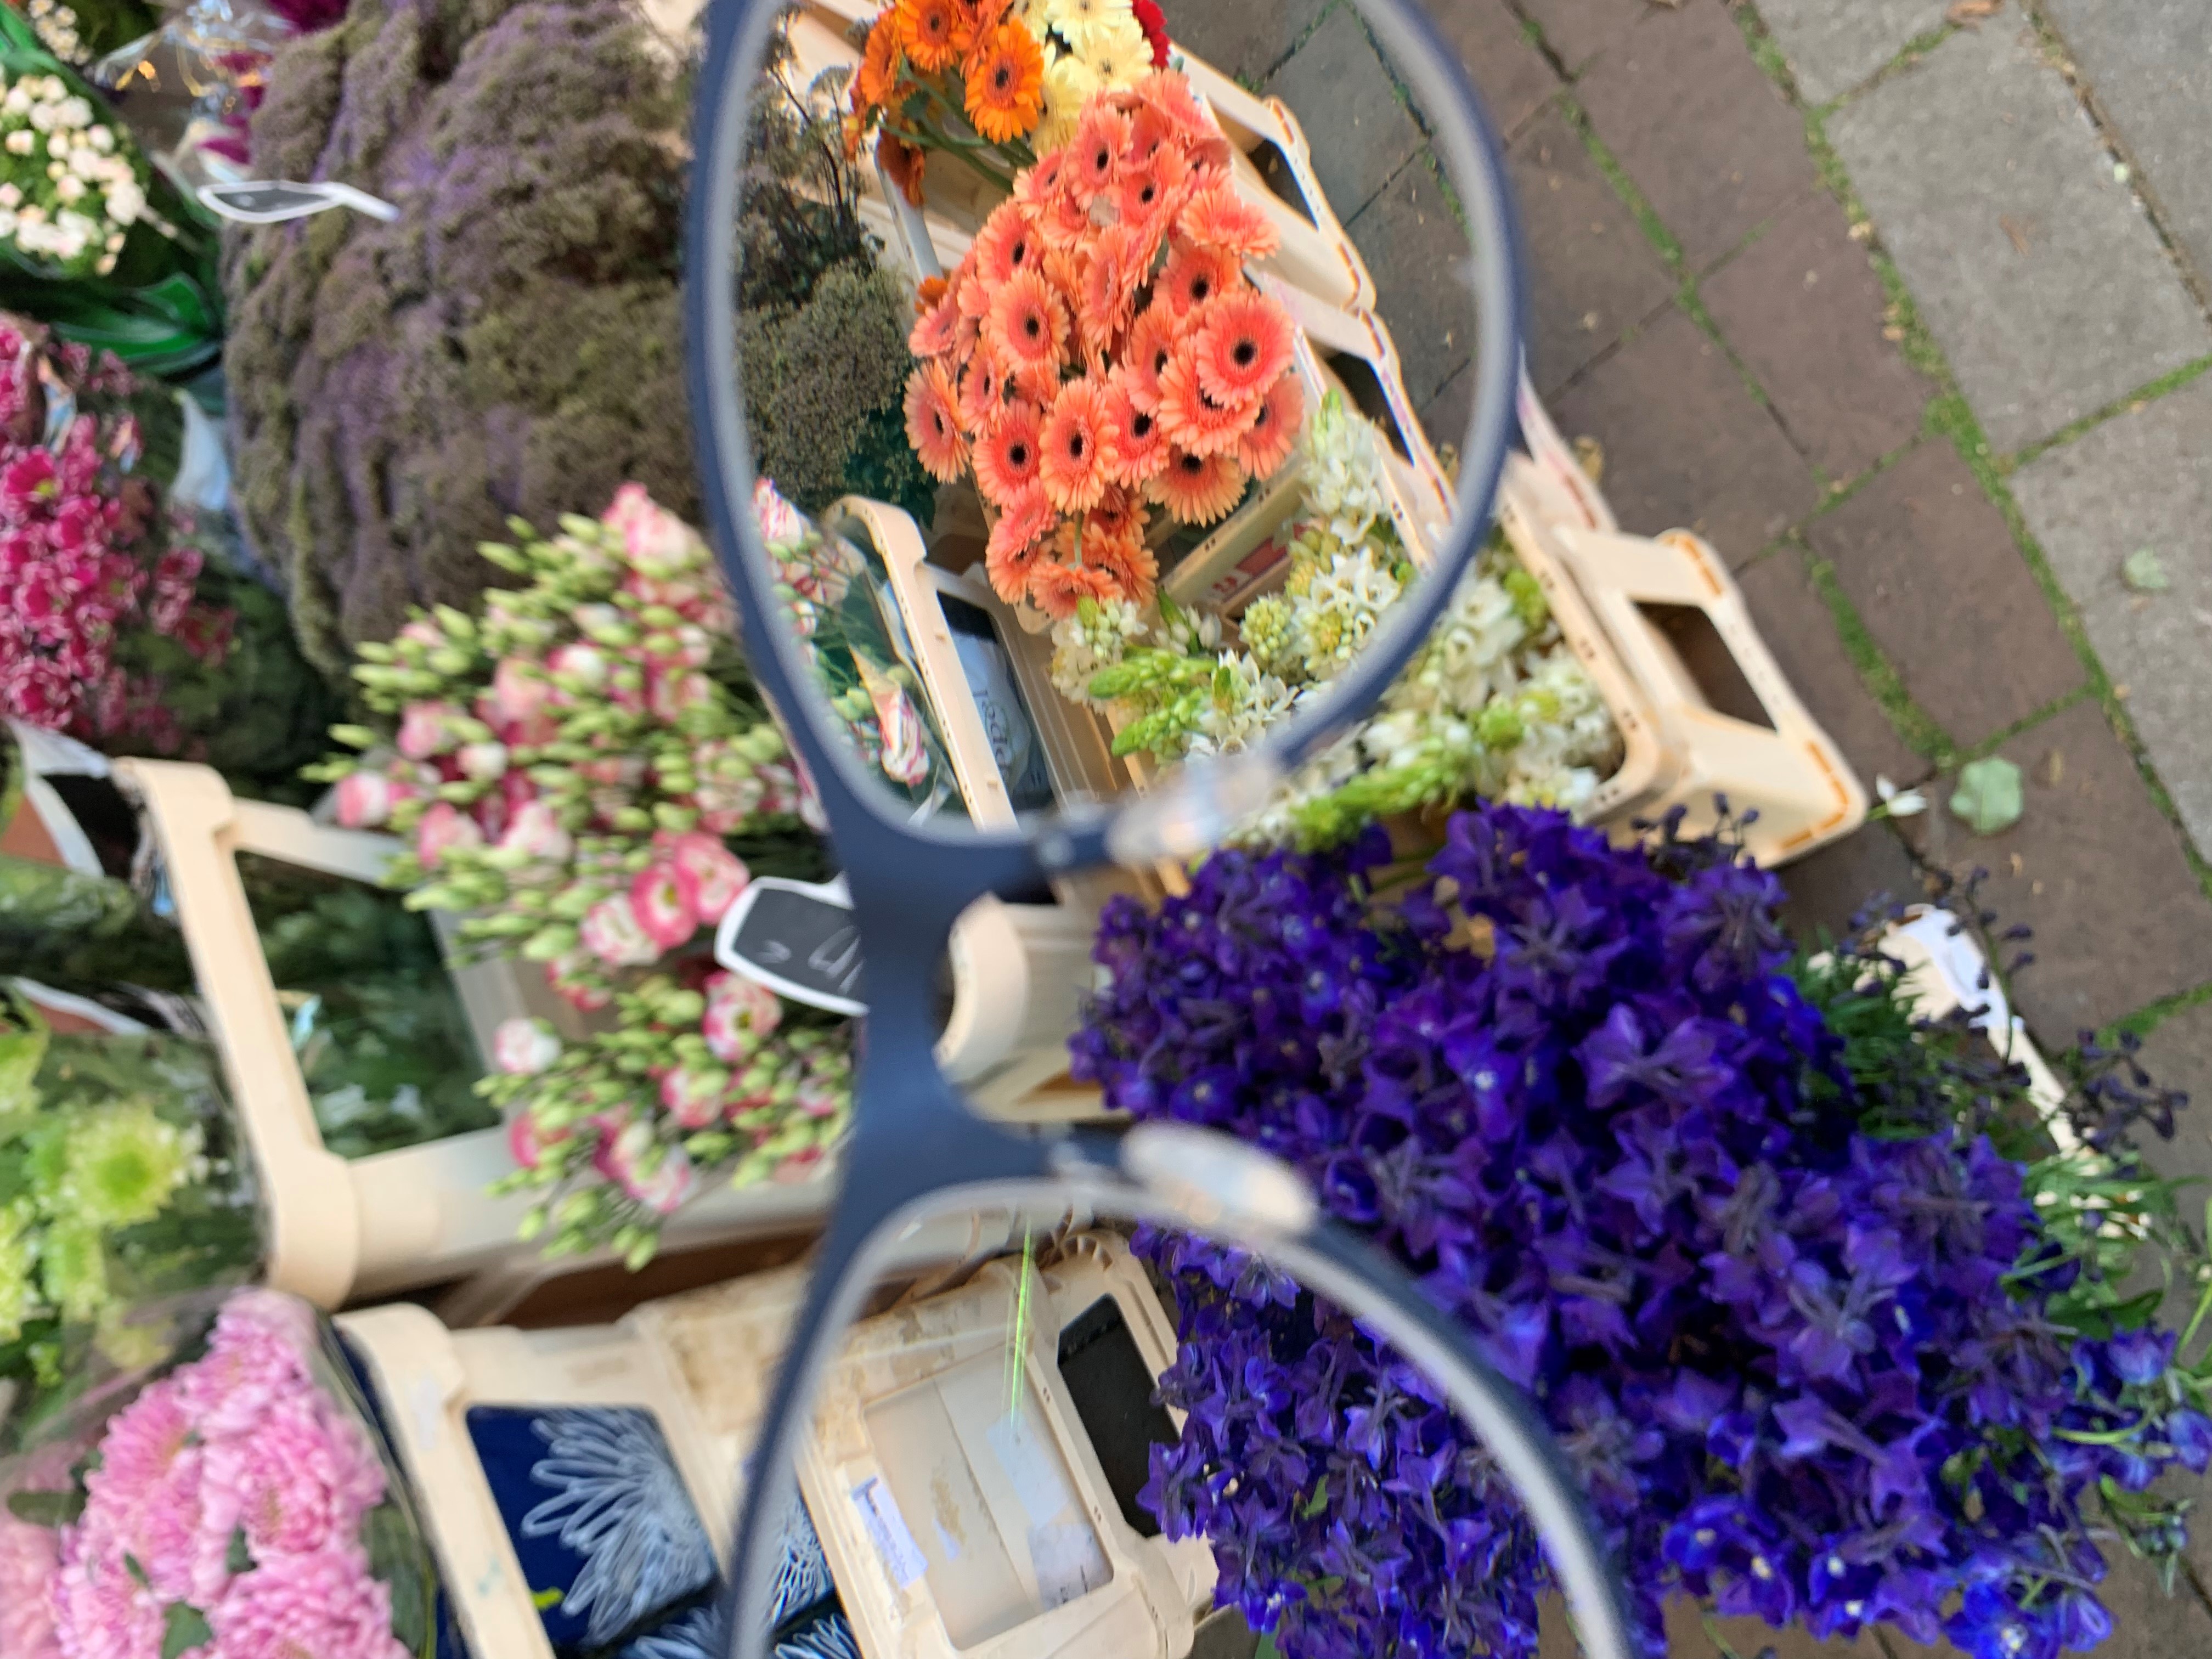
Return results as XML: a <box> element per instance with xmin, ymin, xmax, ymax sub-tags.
<box><xmin>845</xmin><ymin>0</ymin><xmax>1168</xmax><ymax>206</ymax></box>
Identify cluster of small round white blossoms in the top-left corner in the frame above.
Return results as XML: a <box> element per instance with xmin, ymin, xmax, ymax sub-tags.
<box><xmin>0</xmin><ymin>73</ymin><xmax>161</xmax><ymax>276</ymax></box>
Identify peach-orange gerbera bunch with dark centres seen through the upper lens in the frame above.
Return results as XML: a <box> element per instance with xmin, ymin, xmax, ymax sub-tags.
<box><xmin>907</xmin><ymin>71</ymin><xmax>1305</xmax><ymax>617</ymax></box>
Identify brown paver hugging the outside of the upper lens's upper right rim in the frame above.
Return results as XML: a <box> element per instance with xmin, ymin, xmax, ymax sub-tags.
<box><xmin>1506</xmin><ymin>111</ymin><xmax>1674</xmax><ymax>396</ymax></box>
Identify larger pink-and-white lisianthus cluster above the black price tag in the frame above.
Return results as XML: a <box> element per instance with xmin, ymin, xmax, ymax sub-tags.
<box><xmin>303</xmin><ymin>484</ymin><xmax>801</xmax><ymax>1009</ymax></box>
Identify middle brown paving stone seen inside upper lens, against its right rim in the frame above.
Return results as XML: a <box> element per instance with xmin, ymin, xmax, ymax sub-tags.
<box><xmin>1345</xmin><ymin>150</ymin><xmax>1475</xmax><ymax>409</ymax></box>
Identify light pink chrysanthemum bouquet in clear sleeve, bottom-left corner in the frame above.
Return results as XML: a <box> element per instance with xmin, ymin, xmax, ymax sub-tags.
<box><xmin>0</xmin><ymin>1290</ymin><xmax>436</xmax><ymax>1659</ymax></box>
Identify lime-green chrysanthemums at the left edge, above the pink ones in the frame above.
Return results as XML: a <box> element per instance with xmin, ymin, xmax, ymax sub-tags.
<box><xmin>0</xmin><ymin>995</ymin><xmax>259</xmax><ymax>1447</ymax></box>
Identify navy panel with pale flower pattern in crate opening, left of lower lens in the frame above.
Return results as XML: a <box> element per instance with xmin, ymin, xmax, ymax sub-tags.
<box><xmin>469</xmin><ymin>1404</ymin><xmax>714</xmax><ymax>1659</ymax></box>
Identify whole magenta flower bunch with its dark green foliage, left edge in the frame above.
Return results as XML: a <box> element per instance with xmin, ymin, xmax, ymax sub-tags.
<box><xmin>0</xmin><ymin>314</ymin><xmax>334</xmax><ymax>792</ymax></box>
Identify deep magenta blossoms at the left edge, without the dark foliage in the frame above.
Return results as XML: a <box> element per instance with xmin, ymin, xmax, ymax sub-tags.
<box><xmin>0</xmin><ymin>314</ymin><xmax>234</xmax><ymax>754</ymax></box>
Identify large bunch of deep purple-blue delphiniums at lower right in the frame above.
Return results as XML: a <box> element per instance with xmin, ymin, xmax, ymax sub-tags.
<box><xmin>1075</xmin><ymin>805</ymin><xmax>2212</xmax><ymax>1659</ymax></box>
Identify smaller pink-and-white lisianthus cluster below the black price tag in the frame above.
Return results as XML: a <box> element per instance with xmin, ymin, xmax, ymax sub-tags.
<box><xmin>480</xmin><ymin>964</ymin><xmax>851</xmax><ymax>1267</ymax></box>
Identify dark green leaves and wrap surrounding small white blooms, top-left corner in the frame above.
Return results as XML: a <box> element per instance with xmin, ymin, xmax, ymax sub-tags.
<box><xmin>0</xmin><ymin>7</ymin><xmax>223</xmax><ymax>374</ymax></box>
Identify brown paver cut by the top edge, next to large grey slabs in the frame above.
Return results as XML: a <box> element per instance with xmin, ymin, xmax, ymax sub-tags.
<box><xmin>1575</xmin><ymin>0</ymin><xmax>1816</xmax><ymax>270</ymax></box>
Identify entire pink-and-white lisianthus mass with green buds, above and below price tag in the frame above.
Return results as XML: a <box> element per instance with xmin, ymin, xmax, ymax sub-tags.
<box><xmin>323</xmin><ymin>484</ymin><xmax>849</xmax><ymax>1261</ymax></box>
